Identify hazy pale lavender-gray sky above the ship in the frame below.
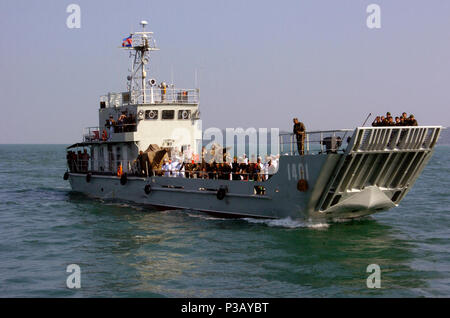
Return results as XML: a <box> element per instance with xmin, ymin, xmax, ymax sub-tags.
<box><xmin>0</xmin><ymin>0</ymin><xmax>450</xmax><ymax>143</ymax></box>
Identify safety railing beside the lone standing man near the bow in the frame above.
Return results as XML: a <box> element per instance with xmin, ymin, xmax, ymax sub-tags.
<box><xmin>279</xmin><ymin>129</ymin><xmax>353</xmax><ymax>156</ymax></box>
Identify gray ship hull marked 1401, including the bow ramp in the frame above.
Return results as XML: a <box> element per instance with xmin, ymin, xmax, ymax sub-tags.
<box><xmin>69</xmin><ymin>127</ymin><xmax>440</xmax><ymax>220</ymax></box>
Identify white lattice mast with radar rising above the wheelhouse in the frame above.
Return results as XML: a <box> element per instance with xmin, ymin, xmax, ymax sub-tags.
<box><xmin>122</xmin><ymin>21</ymin><xmax>159</xmax><ymax>103</ymax></box>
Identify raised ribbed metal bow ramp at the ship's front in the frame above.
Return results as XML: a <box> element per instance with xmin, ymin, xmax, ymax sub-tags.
<box><xmin>317</xmin><ymin>126</ymin><xmax>442</xmax><ymax>214</ymax></box>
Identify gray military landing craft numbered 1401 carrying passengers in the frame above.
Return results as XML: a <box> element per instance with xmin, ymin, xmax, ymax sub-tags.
<box><xmin>64</xmin><ymin>21</ymin><xmax>442</xmax><ymax>220</ymax></box>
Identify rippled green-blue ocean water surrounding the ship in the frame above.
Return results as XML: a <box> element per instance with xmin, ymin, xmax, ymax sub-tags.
<box><xmin>0</xmin><ymin>134</ymin><xmax>450</xmax><ymax>297</ymax></box>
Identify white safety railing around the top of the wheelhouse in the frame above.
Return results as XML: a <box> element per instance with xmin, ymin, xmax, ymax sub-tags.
<box><xmin>100</xmin><ymin>86</ymin><xmax>199</xmax><ymax>108</ymax></box>
